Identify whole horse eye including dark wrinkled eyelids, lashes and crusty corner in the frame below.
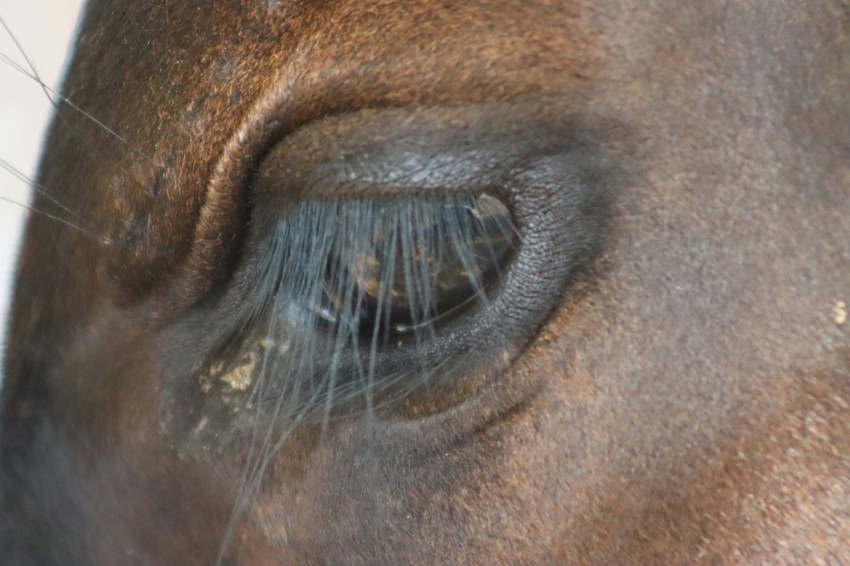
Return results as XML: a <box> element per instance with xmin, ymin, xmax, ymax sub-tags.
<box><xmin>187</xmin><ymin>103</ymin><xmax>616</xmax><ymax>430</ymax></box>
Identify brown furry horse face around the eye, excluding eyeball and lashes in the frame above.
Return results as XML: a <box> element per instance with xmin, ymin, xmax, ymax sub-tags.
<box><xmin>0</xmin><ymin>0</ymin><xmax>850</xmax><ymax>566</ymax></box>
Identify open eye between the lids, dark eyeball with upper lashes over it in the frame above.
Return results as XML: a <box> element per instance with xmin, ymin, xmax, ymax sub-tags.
<box><xmin>255</xmin><ymin>193</ymin><xmax>519</xmax><ymax>342</ymax></box>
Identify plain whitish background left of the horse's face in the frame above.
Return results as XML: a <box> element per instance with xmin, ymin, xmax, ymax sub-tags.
<box><xmin>0</xmin><ymin>0</ymin><xmax>82</xmax><ymax>367</ymax></box>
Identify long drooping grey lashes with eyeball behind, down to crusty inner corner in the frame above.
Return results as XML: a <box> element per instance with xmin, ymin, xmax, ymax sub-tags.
<box><xmin>200</xmin><ymin>193</ymin><xmax>519</xmax><ymax>424</ymax></box>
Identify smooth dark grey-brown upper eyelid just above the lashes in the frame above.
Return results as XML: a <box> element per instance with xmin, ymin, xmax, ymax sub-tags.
<box><xmin>251</xmin><ymin>102</ymin><xmax>587</xmax><ymax>207</ymax></box>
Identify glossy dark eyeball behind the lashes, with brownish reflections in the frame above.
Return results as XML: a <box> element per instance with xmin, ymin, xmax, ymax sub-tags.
<box><xmin>314</xmin><ymin>194</ymin><xmax>516</xmax><ymax>341</ymax></box>
